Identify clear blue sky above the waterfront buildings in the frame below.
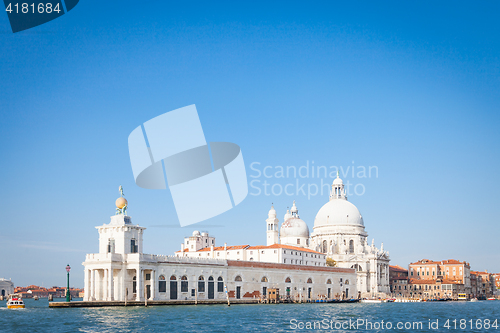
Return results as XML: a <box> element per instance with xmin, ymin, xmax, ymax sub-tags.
<box><xmin>0</xmin><ymin>0</ymin><xmax>500</xmax><ymax>287</ymax></box>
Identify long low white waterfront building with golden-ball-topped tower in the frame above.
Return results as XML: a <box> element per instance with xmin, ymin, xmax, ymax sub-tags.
<box><xmin>83</xmin><ymin>192</ymin><xmax>358</xmax><ymax>301</ymax></box>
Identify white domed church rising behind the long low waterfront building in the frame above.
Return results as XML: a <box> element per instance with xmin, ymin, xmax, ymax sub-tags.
<box><xmin>266</xmin><ymin>175</ymin><xmax>390</xmax><ymax>297</ymax></box>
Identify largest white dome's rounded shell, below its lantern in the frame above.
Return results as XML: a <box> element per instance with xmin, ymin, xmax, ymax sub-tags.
<box><xmin>314</xmin><ymin>199</ymin><xmax>364</xmax><ymax>228</ymax></box>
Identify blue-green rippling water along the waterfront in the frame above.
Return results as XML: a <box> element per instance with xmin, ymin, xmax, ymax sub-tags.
<box><xmin>0</xmin><ymin>299</ymin><xmax>500</xmax><ymax>333</ymax></box>
